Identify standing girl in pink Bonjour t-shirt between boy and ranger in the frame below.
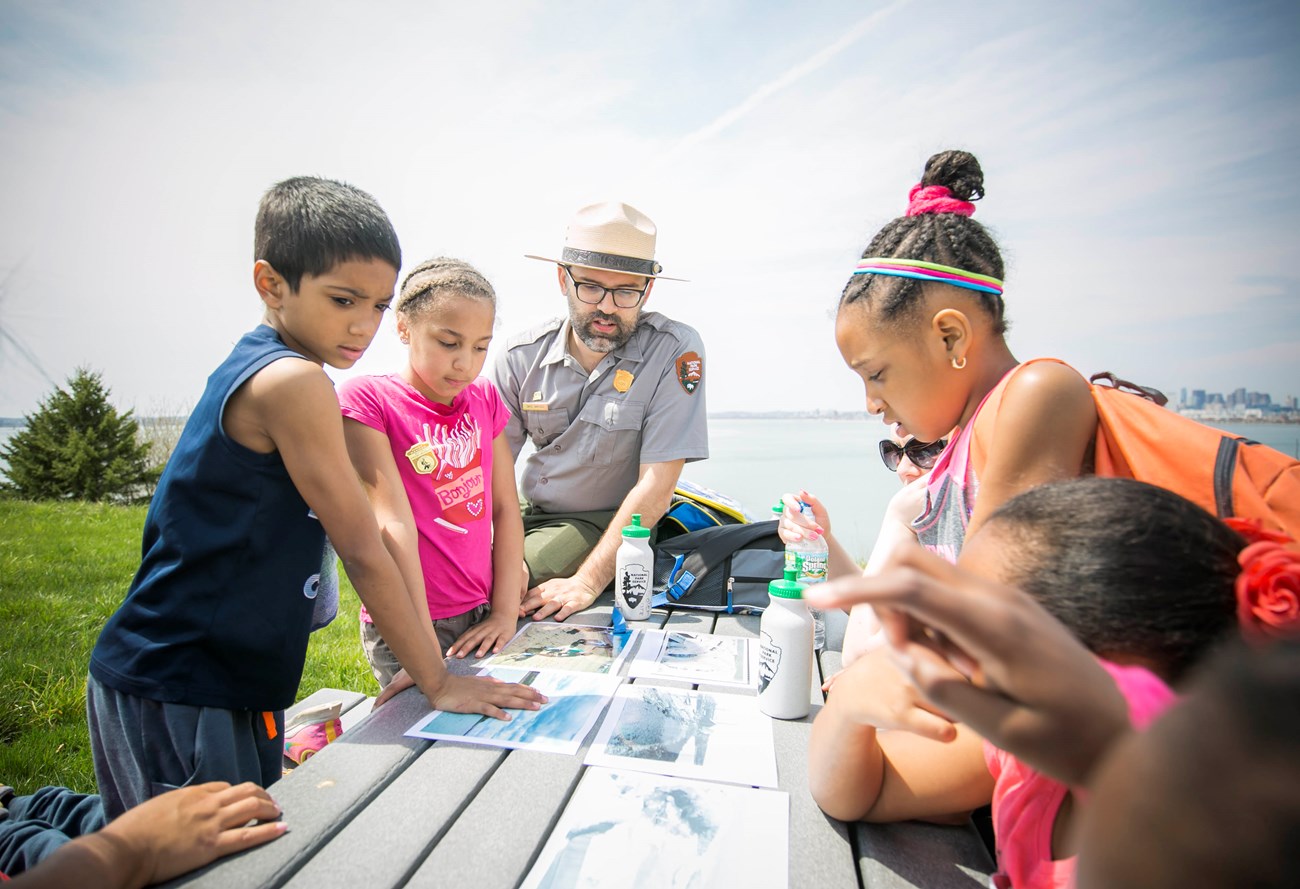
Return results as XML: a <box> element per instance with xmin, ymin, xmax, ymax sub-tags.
<box><xmin>338</xmin><ymin>259</ymin><xmax>524</xmax><ymax>685</ymax></box>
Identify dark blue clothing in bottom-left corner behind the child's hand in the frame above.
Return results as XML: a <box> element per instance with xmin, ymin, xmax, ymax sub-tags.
<box><xmin>0</xmin><ymin>786</ymin><xmax>105</xmax><ymax>877</ymax></box>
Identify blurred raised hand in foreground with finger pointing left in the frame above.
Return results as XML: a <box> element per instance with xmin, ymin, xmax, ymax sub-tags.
<box><xmin>805</xmin><ymin>547</ymin><xmax>1128</xmax><ymax>784</ymax></box>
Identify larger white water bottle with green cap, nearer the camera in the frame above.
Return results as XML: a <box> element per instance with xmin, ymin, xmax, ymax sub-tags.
<box><xmin>758</xmin><ymin>568</ymin><xmax>813</xmax><ymax>719</ymax></box>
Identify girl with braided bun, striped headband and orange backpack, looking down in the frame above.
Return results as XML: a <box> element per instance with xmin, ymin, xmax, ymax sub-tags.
<box><xmin>814</xmin><ymin>151</ymin><xmax>1097</xmax><ymax>560</ymax></box>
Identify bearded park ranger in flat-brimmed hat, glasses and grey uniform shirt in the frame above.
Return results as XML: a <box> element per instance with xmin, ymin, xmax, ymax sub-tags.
<box><xmin>491</xmin><ymin>201</ymin><xmax>709</xmax><ymax>620</ymax></box>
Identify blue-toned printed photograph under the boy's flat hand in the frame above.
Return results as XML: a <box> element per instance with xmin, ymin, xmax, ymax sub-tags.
<box><xmin>406</xmin><ymin>668</ymin><xmax>621</xmax><ymax>755</ymax></box>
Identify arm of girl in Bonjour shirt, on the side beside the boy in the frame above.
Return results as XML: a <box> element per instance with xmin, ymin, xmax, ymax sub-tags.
<box><xmin>343</xmin><ymin>417</ymin><xmax>438</xmax><ymax>645</ymax></box>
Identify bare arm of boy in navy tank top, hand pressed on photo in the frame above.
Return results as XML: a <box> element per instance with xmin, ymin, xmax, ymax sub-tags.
<box><xmin>244</xmin><ymin>360</ymin><xmax>543</xmax><ymax>719</ymax></box>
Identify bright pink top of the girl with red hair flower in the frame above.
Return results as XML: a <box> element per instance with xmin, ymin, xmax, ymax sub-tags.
<box><xmin>984</xmin><ymin>659</ymin><xmax>1177</xmax><ymax>889</ymax></box>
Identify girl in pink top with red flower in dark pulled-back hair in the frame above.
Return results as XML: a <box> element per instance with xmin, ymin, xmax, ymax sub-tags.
<box><xmin>809</xmin><ymin>477</ymin><xmax>1245</xmax><ymax>889</ymax></box>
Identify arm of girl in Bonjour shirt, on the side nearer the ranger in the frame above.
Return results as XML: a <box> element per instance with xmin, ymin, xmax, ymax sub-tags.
<box><xmin>447</xmin><ymin>433</ymin><xmax>524</xmax><ymax>658</ymax></box>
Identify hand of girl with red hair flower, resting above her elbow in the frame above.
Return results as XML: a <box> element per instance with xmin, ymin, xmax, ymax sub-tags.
<box><xmin>828</xmin><ymin>649</ymin><xmax>957</xmax><ymax>741</ymax></box>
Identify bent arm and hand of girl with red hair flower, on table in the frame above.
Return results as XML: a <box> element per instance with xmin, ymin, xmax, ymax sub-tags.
<box><xmin>809</xmin><ymin>644</ymin><xmax>993</xmax><ymax>823</ymax></box>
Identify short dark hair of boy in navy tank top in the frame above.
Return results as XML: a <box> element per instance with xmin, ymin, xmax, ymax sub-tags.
<box><xmin>254</xmin><ymin>175</ymin><xmax>402</xmax><ymax>291</ymax></box>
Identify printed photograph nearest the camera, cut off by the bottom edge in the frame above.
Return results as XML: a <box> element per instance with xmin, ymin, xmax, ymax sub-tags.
<box><xmin>523</xmin><ymin>768</ymin><xmax>790</xmax><ymax>889</ymax></box>
